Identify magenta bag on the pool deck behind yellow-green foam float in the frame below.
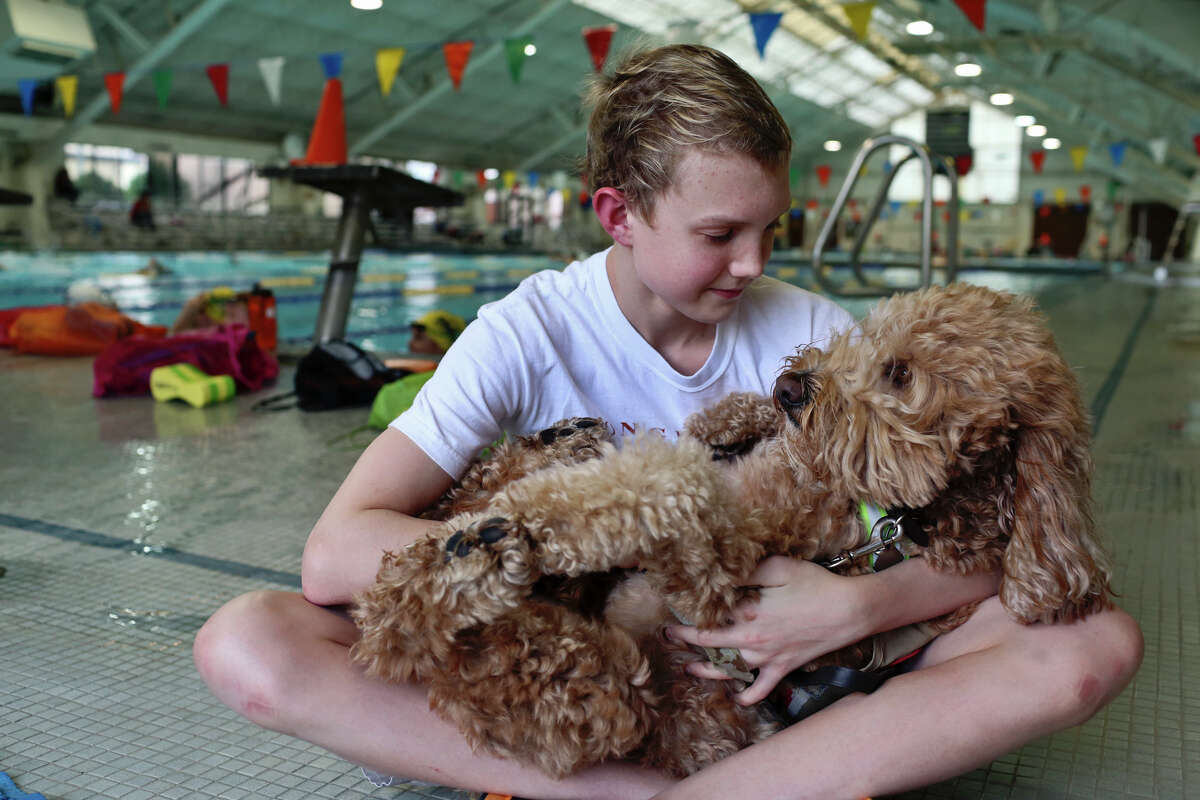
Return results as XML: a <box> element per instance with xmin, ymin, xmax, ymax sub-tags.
<box><xmin>91</xmin><ymin>325</ymin><xmax>280</xmax><ymax>397</ymax></box>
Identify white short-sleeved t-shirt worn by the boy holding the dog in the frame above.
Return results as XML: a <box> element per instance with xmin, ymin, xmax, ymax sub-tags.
<box><xmin>391</xmin><ymin>249</ymin><xmax>853</xmax><ymax>476</ymax></box>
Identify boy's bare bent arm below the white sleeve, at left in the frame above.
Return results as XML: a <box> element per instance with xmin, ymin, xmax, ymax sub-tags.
<box><xmin>300</xmin><ymin>428</ymin><xmax>454</xmax><ymax>606</ymax></box>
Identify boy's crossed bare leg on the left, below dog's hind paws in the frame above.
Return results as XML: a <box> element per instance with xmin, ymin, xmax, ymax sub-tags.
<box><xmin>194</xmin><ymin>591</ymin><xmax>672</xmax><ymax>800</ymax></box>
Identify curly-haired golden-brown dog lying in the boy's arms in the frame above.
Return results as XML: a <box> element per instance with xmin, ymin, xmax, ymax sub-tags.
<box><xmin>353</xmin><ymin>284</ymin><xmax>1109</xmax><ymax>775</ymax></box>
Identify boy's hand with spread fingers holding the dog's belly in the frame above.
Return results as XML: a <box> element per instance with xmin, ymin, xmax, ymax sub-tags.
<box><xmin>667</xmin><ymin>555</ymin><xmax>872</xmax><ymax>705</ymax></box>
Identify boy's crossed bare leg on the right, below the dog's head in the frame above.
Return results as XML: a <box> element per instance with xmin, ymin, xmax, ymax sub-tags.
<box><xmin>659</xmin><ymin>597</ymin><xmax>1142</xmax><ymax>800</ymax></box>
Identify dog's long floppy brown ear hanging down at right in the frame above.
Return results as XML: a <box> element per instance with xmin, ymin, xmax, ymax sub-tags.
<box><xmin>1000</xmin><ymin>353</ymin><xmax>1110</xmax><ymax>622</ymax></box>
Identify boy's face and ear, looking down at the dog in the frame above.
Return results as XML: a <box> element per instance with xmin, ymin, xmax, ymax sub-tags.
<box><xmin>630</xmin><ymin>149</ymin><xmax>791</xmax><ymax>324</ymax></box>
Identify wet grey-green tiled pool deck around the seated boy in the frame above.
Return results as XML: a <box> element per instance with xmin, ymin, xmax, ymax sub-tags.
<box><xmin>0</xmin><ymin>276</ymin><xmax>1200</xmax><ymax>800</ymax></box>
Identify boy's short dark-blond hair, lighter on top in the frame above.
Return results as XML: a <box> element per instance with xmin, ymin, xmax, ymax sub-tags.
<box><xmin>584</xmin><ymin>44</ymin><xmax>792</xmax><ymax>222</ymax></box>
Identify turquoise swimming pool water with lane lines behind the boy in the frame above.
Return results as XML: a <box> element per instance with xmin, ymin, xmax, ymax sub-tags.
<box><xmin>0</xmin><ymin>251</ymin><xmax>1089</xmax><ymax>353</ymax></box>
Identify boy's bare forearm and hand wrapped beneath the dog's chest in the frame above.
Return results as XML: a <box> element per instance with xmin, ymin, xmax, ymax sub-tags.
<box><xmin>670</xmin><ymin>557</ymin><xmax>998</xmax><ymax>704</ymax></box>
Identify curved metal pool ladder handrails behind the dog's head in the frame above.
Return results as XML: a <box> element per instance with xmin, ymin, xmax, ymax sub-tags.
<box><xmin>812</xmin><ymin>133</ymin><xmax>959</xmax><ymax>297</ymax></box>
